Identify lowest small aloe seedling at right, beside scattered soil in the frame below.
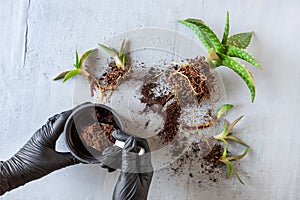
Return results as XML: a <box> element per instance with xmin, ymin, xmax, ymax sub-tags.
<box><xmin>219</xmin><ymin>147</ymin><xmax>249</xmax><ymax>184</ymax></box>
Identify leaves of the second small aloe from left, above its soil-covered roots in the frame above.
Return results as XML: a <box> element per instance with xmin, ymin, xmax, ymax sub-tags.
<box><xmin>98</xmin><ymin>38</ymin><xmax>126</xmax><ymax>71</ymax></box>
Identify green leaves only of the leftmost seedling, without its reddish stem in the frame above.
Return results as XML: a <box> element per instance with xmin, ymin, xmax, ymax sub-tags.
<box><xmin>53</xmin><ymin>49</ymin><xmax>94</xmax><ymax>82</ymax></box>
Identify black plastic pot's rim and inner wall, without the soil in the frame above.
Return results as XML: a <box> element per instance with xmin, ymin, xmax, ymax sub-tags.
<box><xmin>64</xmin><ymin>104</ymin><xmax>124</xmax><ymax>163</ymax></box>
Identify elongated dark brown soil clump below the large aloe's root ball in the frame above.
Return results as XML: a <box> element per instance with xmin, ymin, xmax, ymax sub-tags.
<box><xmin>158</xmin><ymin>101</ymin><xmax>181</xmax><ymax>144</ymax></box>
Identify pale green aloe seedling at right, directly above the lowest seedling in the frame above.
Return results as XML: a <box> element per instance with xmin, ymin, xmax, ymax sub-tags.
<box><xmin>213</xmin><ymin>116</ymin><xmax>249</xmax><ymax>147</ymax></box>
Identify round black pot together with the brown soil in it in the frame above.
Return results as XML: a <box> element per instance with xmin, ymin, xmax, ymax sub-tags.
<box><xmin>64</xmin><ymin>104</ymin><xmax>124</xmax><ymax>163</ymax></box>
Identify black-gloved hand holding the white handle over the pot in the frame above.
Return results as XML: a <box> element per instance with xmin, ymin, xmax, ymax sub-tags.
<box><xmin>113</xmin><ymin>130</ymin><xmax>153</xmax><ymax>200</ymax></box>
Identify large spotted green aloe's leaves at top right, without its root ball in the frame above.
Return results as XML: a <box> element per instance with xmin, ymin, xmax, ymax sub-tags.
<box><xmin>178</xmin><ymin>12</ymin><xmax>261</xmax><ymax>102</ymax></box>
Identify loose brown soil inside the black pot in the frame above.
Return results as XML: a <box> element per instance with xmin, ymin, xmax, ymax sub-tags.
<box><xmin>80</xmin><ymin>109</ymin><xmax>118</xmax><ymax>152</ymax></box>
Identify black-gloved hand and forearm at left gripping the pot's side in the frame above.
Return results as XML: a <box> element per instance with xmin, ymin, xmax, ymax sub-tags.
<box><xmin>0</xmin><ymin>110</ymin><xmax>78</xmax><ymax>195</ymax></box>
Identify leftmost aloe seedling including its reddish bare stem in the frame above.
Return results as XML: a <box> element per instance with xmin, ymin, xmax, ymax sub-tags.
<box><xmin>53</xmin><ymin>49</ymin><xmax>100</xmax><ymax>96</ymax></box>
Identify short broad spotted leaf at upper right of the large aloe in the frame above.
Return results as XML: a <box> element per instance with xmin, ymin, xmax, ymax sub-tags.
<box><xmin>227</xmin><ymin>32</ymin><xmax>253</xmax><ymax>49</ymax></box>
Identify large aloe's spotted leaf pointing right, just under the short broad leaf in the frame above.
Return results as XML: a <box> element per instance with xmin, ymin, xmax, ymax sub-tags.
<box><xmin>226</xmin><ymin>46</ymin><xmax>262</xmax><ymax>69</ymax></box>
